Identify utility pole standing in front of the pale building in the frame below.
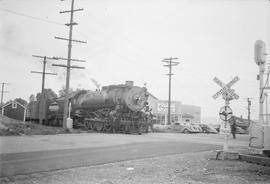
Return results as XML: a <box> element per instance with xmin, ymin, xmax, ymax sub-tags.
<box><xmin>162</xmin><ymin>57</ymin><xmax>179</xmax><ymax>125</ymax></box>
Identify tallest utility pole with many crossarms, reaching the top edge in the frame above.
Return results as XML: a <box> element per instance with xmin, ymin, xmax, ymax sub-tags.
<box><xmin>53</xmin><ymin>0</ymin><xmax>86</xmax><ymax>128</ymax></box>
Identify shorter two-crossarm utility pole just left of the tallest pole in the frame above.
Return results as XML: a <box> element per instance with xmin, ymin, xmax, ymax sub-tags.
<box><xmin>31</xmin><ymin>55</ymin><xmax>57</xmax><ymax>124</ymax></box>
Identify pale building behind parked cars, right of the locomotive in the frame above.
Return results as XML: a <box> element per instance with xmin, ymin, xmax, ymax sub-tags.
<box><xmin>148</xmin><ymin>94</ymin><xmax>201</xmax><ymax>125</ymax></box>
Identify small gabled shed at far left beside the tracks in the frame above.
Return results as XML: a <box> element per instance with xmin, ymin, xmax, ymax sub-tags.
<box><xmin>2</xmin><ymin>101</ymin><xmax>26</xmax><ymax>121</ymax></box>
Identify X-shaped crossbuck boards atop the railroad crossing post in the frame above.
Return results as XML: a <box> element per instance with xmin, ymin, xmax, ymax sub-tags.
<box><xmin>213</xmin><ymin>77</ymin><xmax>239</xmax><ymax>100</ymax></box>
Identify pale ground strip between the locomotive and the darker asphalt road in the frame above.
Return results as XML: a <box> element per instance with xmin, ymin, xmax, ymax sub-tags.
<box><xmin>0</xmin><ymin>133</ymin><xmax>248</xmax><ymax>154</ymax></box>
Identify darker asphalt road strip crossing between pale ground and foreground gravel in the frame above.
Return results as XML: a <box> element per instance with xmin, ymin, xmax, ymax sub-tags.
<box><xmin>0</xmin><ymin>142</ymin><xmax>220</xmax><ymax>177</ymax></box>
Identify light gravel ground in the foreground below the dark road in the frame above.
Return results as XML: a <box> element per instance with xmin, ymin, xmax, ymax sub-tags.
<box><xmin>0</xmin><ymin>152</ymin><xmax>270</xmax><ymax>184</ymax></box>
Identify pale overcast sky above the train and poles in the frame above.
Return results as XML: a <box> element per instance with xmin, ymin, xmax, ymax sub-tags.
<box><xmin>0</xmin><ymin>0</ymin><xmax>270</xmax><ymax>118</ymax></box>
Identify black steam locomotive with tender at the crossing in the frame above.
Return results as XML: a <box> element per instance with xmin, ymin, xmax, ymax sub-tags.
<box><xmin>30</xmin><ymin>82</ymin><xmax>151</xmax><ymax>133</ymax></box>
